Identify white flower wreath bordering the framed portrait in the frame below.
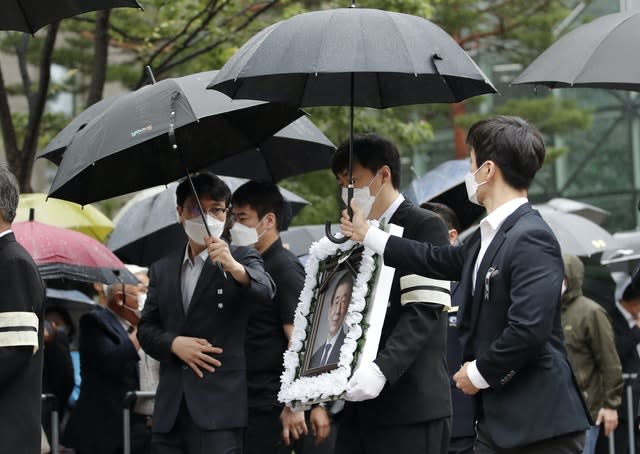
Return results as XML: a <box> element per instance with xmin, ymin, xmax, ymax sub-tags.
<box><xmin>278</xmin><ymin>221</ymin><xmax>379</xmax><ymax>409</ymax></box>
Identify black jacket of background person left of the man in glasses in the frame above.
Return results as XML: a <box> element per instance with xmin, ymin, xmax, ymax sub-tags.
<box><xmin>63</xmin><ymin>307</ymin><xmax>140</xmax><ymax>454</ymax></box>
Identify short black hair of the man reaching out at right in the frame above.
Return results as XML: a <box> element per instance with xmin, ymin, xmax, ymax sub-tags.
<box><xmin>467</xmin><ymin>115</ymin><xmax>545</xmax><ymax>189</ymax></box>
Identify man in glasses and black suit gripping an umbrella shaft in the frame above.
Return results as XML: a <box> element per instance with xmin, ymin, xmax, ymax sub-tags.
<box><xmin>139</xmin><ymin>173</ymin><xmax>274</xmax><ymax>454</ymax></box>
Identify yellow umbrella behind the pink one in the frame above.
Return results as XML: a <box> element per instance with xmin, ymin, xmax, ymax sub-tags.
<box><xmin>15</xmin><ymin>193</ymin><xmax>114</xmax><ymax>242</ymax></box>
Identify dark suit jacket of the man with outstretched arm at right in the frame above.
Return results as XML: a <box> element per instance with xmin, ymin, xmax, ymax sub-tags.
<box><xmin>384</xmin><ymin>203</ymin><xmax>590</xmax><ymax>448</ymax></box>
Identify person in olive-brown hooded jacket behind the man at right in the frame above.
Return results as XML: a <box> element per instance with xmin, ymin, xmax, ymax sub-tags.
<box><xmin>560</xmin><ymin>254</ymin><xmax>623</xmax><ymax>454</ymax></box>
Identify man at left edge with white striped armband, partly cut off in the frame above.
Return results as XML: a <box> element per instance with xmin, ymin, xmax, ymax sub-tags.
<box><xmin>0</xmin><ymin>165</ymin><xmax>45</xmax><ymax>454</ymax></box>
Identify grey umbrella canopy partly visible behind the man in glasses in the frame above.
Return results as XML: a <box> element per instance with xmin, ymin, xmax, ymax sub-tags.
<box><xmin>107</xmin><ymin>176</ymin><xmax>309</xmax><ymax>266</ymax></box>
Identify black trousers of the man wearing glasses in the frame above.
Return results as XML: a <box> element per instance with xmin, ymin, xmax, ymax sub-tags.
<box><xmin>151</xmin><ymin>401</ymin><xmax>244</xmax><ymax>454</ymax></box>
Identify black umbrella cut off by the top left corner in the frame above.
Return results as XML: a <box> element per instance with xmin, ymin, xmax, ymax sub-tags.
<box><xmin>0</xmin><ymin>0</ymin><xmax>142</xmax><ymax>34</ymax></box>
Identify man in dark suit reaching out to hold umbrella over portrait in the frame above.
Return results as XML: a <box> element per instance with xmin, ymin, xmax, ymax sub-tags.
<box><xmin>341</xmin><ymin>116</ymin><xmax>590</xmax><ymax>454</ymax></box>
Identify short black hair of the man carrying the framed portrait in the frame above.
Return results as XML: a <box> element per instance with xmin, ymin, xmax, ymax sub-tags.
<box><xmin>331</xmin><ymin>133</ymin><xmax>400</xmax><ymax>189</ymax></box>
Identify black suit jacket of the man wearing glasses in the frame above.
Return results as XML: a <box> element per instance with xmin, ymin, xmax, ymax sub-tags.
<box><xmin>138</xmin><ymin>247</ymin><xmax>274</xmax><ymax>433</ymax></box>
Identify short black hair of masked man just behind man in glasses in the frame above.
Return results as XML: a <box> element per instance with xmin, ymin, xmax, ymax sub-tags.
<box><xmin>231</xmin><ymin>180</ymin><xmax>286</xmax><ymax>230</ymax></box>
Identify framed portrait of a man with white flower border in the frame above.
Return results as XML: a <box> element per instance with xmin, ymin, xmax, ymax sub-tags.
<box><xmin>278</xmin><ymin>221</ymin><xmax>402</xmax><ymax>409</ymax></box>
